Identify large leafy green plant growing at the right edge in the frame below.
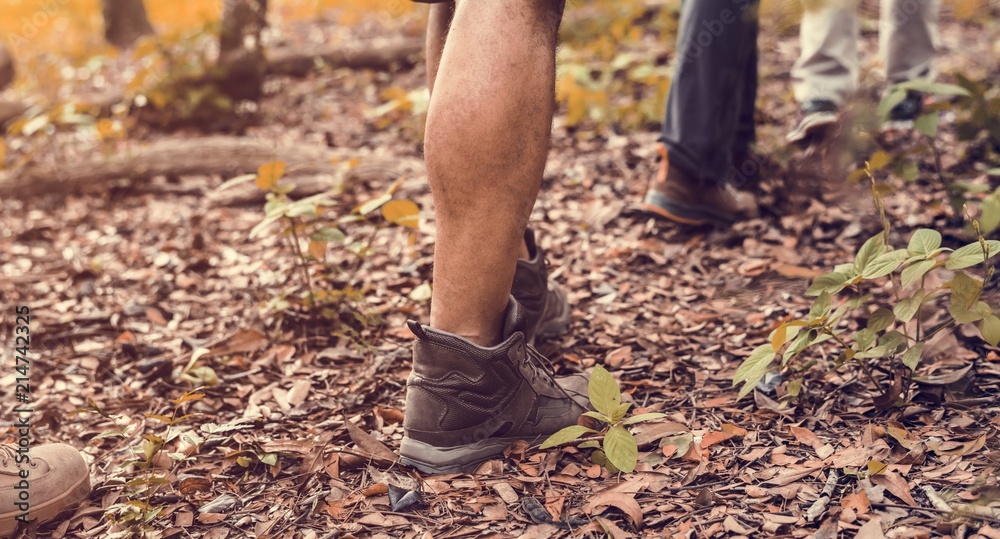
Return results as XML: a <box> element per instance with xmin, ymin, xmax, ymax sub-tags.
<box><xmin>733</xmin><ymin>168</ymin><xmax>1000</xmax><ymax>407</ymax></box>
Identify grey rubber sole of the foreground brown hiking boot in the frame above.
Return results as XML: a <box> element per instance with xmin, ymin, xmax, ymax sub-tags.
<box><xmin>399</xmin><ymin>436</ymin><xmax>523</xmax><ymax>475</ymax></box>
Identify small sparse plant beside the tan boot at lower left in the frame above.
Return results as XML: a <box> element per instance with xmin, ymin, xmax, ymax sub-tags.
<box><xmin>79</xmin><ymin>391</ymin><xmax>205</xmax><ymax>539</ymax></box>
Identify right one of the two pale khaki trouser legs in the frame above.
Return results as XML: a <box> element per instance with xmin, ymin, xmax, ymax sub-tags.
<box><xmin>879</xmin><ymin>0</ymin><xmax>941</xmax><ymax>84</ymax></box>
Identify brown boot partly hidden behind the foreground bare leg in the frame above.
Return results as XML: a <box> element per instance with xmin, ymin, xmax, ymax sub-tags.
<box><xmin>510</xmin><ymin>228</ymin><xmax>570</xmax><ymax>345</ymax></box>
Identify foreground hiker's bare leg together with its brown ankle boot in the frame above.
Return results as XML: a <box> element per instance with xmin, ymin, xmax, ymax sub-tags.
<box><xmin>399</xmin><ymin>0</ymin><xmax>588</xmax><ymax>473</ymax></box>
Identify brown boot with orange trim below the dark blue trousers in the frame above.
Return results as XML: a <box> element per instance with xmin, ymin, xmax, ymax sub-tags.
<box><xmin>642</xmin><ymin>143</ymin><xmax>757</xmax><ymax>225</ymax></box>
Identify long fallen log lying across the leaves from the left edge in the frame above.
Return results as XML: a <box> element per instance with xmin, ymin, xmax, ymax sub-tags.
<box><xmin>0</xmin><ymin>136</ymin><xmax>419</xmax><ymax>198</ymax></box>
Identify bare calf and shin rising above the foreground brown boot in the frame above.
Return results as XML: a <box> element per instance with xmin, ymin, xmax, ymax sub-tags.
<box><xmin>425</xmin><ymin>0</ymin><xmax>562</xmax><ymax>346</ymax></box>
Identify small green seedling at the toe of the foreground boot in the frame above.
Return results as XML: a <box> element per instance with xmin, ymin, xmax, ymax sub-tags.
<box><xmin>541</xmin><ymin>365</ymin><xmax>666</xmax><ymax>473</ymax></box>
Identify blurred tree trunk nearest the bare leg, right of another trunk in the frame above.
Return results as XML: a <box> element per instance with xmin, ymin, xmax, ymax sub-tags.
<box><xmin>218</xmin><ymin>0</ymin><xmax>267</xmax><ymax>101</ymax></box>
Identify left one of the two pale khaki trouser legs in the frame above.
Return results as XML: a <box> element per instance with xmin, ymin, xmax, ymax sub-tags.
<box><xmin>792</xmin><ymin>0</ymin><xmax>858</xmax><ymax>105</ymax></box>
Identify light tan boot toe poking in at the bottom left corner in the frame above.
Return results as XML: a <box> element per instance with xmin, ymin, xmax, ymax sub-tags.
<box><xmin>0</xmin><ymin>444</ymin><xmax>90</xmax><ymax>537</ymax></box>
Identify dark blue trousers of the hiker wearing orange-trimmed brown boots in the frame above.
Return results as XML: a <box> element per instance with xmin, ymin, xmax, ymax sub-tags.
<box><xmin>660</xmin><ymin>0</ymin><xmax>758</xmax><ymax>186</ymax></box>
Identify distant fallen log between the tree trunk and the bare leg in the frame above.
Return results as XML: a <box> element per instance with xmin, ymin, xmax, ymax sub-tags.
<box><xmin>267</xmin><ymin>39</ymin><xmax>424</xmax><ymax>77</ymax></box>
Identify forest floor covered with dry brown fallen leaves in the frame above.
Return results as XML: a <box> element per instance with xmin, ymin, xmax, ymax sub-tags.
<box><xmin>0</xmin><ymin>4</ymin><xmax>1000</xmax><ymax>539</ymax></box>
